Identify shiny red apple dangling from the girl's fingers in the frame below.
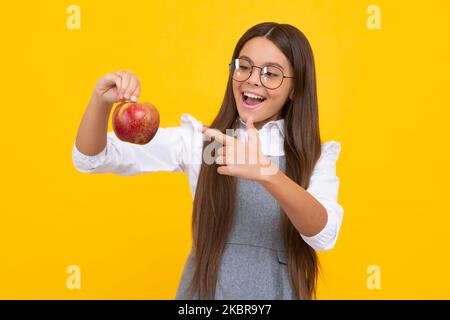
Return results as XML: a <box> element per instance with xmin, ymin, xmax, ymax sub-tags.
<box><xmin>112</xmin><ymin>101</ymin><xmax>159</xmax><ymax>144</ymax></box>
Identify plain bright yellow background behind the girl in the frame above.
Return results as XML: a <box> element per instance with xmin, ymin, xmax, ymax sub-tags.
<box><xmin>0</xmin><ymin>0</ymin><xmax>450</xmax><ymax>299</ymax></box>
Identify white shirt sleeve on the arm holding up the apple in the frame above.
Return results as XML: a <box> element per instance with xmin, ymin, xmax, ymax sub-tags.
<box><xmin>72</xmin><ymin>114</ymin><xmax>199</xmax><ymax>176</ymax></box>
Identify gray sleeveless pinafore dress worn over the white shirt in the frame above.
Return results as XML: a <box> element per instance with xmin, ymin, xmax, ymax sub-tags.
<box><xmin>175</xmin><ymin>156</ymin><xmax>295</xmax><ymax>300</ymax></box>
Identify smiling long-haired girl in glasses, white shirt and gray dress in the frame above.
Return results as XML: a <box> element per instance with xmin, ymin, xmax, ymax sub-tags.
<box><xmin>72</xmin><ymin>23</ymin><xmax>343</xmax><ymax>299</ymax></box>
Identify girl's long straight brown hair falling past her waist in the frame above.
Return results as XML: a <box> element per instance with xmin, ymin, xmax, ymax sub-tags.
<box><xmin>185</xmin><ymin>22</ymin><xmax>321</xmax><ymax>299</ymax></box>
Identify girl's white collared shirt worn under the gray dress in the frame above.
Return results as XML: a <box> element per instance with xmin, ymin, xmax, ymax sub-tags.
<box><xmin>72</xmin><ymin>113</ymin><xmax>344</xmax><ymax>251</ymax></box>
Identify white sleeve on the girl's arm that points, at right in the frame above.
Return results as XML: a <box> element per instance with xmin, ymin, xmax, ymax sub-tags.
<box><xmin>300</xmin><ymin>141</ymin><xmax>344</xmax><ymax>251</ymax></box>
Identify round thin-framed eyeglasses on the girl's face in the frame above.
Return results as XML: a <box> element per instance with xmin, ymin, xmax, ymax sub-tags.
<box><xmin>228</xmin><ymin>58</ymin><xmax>294</xmax><ymax>90</ymax></box>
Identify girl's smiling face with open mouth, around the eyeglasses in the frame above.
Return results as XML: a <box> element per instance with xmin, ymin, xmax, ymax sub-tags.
<box><xmin>232</xmin><ymin>37</ymin><xmax>294</xmax><ymax>129</ymax></box>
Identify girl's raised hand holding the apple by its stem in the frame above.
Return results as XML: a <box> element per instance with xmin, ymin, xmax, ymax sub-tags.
<box><xmin>94</xmin><ymin>71</ymin><xmax>141</xmax><ymax>104</ymax></box>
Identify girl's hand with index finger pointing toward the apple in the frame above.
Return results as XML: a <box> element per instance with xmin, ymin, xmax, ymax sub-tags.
<box><xmin>199</xmin><ymin>117</ymin><xmax>278</xmax><ymax>181</ymax></box>
